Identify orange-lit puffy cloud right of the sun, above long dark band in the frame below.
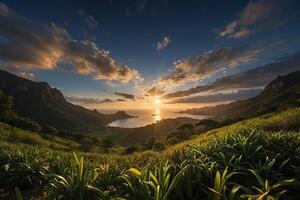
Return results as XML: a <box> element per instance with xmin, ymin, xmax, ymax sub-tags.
<box><xmin>159</xmin><ymin>46</ymin><xmax>265</xmax><ymax>84</ymax></box>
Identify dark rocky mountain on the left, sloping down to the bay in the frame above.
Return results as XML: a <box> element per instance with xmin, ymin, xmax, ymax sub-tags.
<box><xmin>0</xmin><ymin>70</ymin><xmax>131</xmax><ymax>132</ymax></box>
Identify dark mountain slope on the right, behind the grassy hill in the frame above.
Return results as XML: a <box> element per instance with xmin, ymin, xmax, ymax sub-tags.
<box><xmin>181</xmin><ymin>71</ymin><xmax>300</xmax><ymax>120</ymax></box>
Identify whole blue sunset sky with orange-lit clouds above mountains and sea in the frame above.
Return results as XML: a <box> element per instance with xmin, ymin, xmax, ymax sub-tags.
<box><xmin>0</xmin><ymin>0</ymin><xmax>300</xmax><ymax>109</ymax></box>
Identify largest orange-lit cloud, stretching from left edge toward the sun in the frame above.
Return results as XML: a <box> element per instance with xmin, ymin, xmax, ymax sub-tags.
<box><xmin>0</xmin><ymin>4</ymin><xmax>142</xmax><ymax>83</ymax></box>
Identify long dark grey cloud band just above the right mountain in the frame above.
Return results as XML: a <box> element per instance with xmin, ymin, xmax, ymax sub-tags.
<box><xmin>164</xmin><ymin>52</ymin><xmax>300</xmax><ymax>98</ymax></box>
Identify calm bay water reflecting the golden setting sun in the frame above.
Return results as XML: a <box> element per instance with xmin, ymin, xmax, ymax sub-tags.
<box><xmin>98</xmin><ymin>109</ymin><xmax>206</xmax><ymax>128</ymax></box>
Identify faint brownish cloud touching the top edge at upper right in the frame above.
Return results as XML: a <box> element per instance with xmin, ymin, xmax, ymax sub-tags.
<box><xmin>219</xmin><ymin>0</ymin><xmax>286</xmax><ymax>39</ymax></box>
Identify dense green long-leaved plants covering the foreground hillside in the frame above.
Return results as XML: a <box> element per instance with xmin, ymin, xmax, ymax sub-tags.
<box><xmin>0</xmin><ymin>108</ymin><xmax>300</xmax><ymax>200</ymax></box>
